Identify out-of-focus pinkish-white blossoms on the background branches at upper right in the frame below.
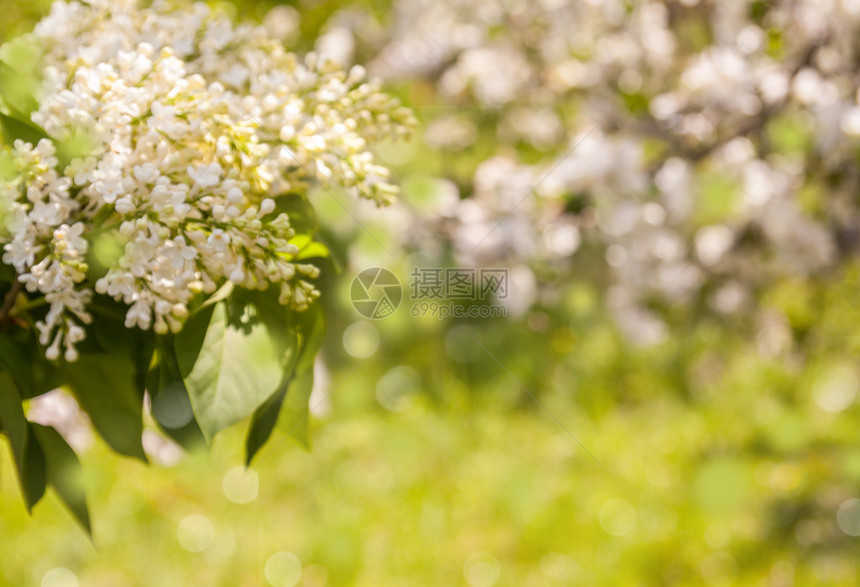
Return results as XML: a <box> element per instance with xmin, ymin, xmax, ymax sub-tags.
<box><xmin>328</xmin><ymin>0</ymin><xmax>860</xmax><ymax>342</ymax></box>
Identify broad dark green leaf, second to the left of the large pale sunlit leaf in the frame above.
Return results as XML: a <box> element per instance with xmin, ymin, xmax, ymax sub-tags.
<box><xmin>63</xmin><ymin>353</ymin><xmax>146</xmax><ymax>462</ymax></box>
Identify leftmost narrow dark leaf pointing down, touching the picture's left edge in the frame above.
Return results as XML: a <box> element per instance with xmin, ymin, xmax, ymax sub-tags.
<box><xmin>0</xmin><ymin>372</ymin><xmax>46</xmax><ymax>511</ymax></box>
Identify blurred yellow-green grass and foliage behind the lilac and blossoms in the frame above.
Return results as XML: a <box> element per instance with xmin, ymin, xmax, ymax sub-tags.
<box><xmin>5</xmin><ymin>0</ymin><xmax>860</xmax><ymax>587</ymax></box>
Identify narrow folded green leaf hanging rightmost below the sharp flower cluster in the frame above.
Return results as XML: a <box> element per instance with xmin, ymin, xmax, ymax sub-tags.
<box><xmin>245</xmin><ymin>304</ymin><xmax>324</xmax><ymax>465</ymax></box>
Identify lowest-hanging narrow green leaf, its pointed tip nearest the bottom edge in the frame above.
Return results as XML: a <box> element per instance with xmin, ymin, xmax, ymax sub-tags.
<box><xmin>31</xmin><ymin>424</ymin><xmax>93</xmax><ymax>536</ymax></box>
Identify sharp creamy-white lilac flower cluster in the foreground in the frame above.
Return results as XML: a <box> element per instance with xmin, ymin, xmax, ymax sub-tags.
<box><xmin>0</xmin><ymin>0</ymin><xmax>413</xmax><ymax>360</ymax></box>
